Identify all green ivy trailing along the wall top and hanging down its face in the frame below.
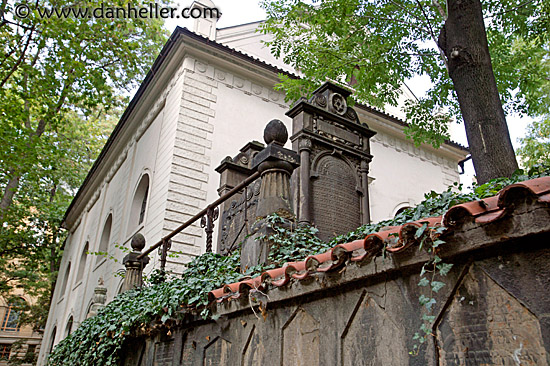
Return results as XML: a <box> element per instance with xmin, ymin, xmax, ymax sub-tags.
<box><xmin>48</xmin><ymin>168</ymin><xmax>550</xmax><ymax>366</ymax></box>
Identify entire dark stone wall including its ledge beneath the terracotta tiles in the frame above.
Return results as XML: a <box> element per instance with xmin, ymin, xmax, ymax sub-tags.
<box><xmin>117</xmin><ymin>186</ymin><xmax>550</xmax><ymax>366</ymax></box>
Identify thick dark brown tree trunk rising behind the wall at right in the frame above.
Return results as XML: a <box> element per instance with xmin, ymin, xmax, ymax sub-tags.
<box><xmin>438</xmin><ymin>0</ymin><xmax>518</xmax><ymax>183</ymax></box>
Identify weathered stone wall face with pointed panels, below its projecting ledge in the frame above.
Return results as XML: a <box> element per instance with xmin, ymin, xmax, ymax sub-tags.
<box><xmin>119</xmin><ymin>237</ymin><xmax>550</xmax><ymax>366</ymax></box>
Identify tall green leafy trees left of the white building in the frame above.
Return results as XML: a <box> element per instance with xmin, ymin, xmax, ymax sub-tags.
<box><xmin>0</xmin><ymin>0</ymin><xmax>170</xmax><ymax>327</ymax></box>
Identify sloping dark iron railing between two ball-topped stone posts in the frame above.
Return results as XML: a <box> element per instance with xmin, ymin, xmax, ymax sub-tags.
<box><xmin>137</xmin><ymin>172</ymin><xmax>261</xmax><ymax>272</ymax></box>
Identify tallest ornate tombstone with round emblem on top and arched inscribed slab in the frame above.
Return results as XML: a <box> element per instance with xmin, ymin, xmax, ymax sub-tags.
<box><xmin>287</xmin><ymin>82</ymin><xmax>376</xmax><ymax>240</ymax></box>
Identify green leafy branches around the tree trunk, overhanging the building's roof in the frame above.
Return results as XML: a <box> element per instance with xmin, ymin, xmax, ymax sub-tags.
<box><xmin>262</xmin><ymin>0</ymin><xmax>550</xmax><ymax>146</ymax></box>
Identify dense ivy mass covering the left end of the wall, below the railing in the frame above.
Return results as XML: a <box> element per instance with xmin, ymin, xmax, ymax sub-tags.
<box><xmin>49</xmin><ymin>251</ymin><xmax>242</xmax><ymax>366</ymax></box>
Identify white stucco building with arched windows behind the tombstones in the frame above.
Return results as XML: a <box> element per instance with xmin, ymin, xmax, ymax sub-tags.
<box><xmin>39</xmin><ymin>4</ymin><xmax>467</xmax><ymax>364</ymax></box>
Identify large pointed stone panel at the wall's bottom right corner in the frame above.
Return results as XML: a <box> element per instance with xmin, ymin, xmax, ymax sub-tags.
<box><xmin>437</xmin><ymin>266</ymin><xmax>546</xmax><ymax>366</ymax></box>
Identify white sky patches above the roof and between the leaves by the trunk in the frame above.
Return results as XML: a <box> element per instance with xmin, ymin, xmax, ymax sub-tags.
<box><xmin>166</xmin><ymin>0</ymin><xmax>532</xmax><ymax>186</ymax></box>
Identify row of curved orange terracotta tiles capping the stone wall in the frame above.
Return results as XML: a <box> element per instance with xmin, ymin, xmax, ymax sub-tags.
<box><xmin>208</xmin><ymin>177</ymin><xmax>550</xmax><ymax>302</ymax></box>
